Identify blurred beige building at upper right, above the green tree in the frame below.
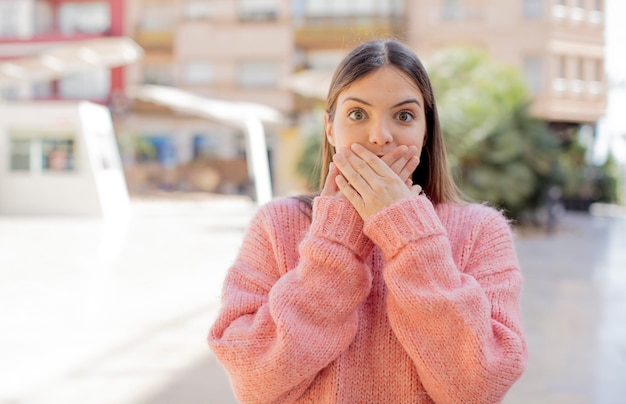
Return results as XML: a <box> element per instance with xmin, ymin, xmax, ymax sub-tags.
<box><xmin>406</xmin><ymin>0</ymin><xmax>607</xmax><ymax>130</ymax></box>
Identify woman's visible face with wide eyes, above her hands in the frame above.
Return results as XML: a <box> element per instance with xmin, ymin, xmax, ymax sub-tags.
<box><xmin>324</xmin><ymin>66</ymin><xmax>426</xmax><ymax>161</ymax></box>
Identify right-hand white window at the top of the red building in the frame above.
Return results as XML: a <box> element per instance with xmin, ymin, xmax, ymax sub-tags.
<box><xmin>59</xmin><ymin>2</ymin><xmax>111</xmax><ymax>35</ymax></box>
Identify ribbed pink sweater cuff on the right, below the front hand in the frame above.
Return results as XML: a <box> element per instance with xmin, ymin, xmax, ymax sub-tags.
<box><xmin>363</xmin><ymin>195</ymin><xmax>446</xmax><ymax>259</ymax></box>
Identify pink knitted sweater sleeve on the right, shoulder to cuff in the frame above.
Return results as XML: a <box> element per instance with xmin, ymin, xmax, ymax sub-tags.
<box><xmin>364</xmin><ymin>196</ymin><xmax>527</xmax><ymax>403</ymax></box>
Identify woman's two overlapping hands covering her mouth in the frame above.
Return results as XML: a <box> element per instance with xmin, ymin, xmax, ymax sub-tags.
<box><xmin>332</xmin><ymin>143</ymin><xmax>422</xmax><ymax>220</ymax></box>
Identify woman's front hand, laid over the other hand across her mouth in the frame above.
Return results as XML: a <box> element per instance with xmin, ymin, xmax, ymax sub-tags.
<box><xmin>333</xmin><ymin>143</ymin><xmax>422</xmax><ymax>220</ymax></box>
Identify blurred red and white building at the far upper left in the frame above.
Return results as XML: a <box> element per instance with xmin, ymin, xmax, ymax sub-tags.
<box><xmin>0</xmin><ymin>0</ymin><xmax>126</xmax><ymax>104</ymax></box>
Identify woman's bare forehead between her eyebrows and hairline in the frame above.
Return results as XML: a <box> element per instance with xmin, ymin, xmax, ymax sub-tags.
<box><xmin>339</xmin><ymin>65</ymin><xmax>423</xmax><ymax>102</ymax></box>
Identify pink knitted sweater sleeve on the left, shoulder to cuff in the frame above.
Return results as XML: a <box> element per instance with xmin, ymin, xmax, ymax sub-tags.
<box><xmin>208</xmin><ymin>197</ymin><xmax>373</xmax><ymax>403</ymax></box>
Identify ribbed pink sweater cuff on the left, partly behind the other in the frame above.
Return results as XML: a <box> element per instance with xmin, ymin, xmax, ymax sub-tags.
<box><xmin>310</xmin><ymin>196</ymin><xmax>374</xmax><ymax>260</ymax></box>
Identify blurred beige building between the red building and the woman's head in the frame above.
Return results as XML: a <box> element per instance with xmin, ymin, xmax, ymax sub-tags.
<box><xmin>119</xmin><ymin>0</ymin><xmax>293</xmax><ymax>196</ymax></box>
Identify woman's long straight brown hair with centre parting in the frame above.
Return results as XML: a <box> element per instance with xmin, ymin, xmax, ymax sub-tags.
<box><xmin>299</xmin><ymin>39</ymin><xmax>463</xmax><ymax>210</ymax></box>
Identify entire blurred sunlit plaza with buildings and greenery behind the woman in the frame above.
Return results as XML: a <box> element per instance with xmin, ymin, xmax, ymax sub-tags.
<box><xmin>0</xmin><ymin>0</ymin><xmax>626</xmax><ymax>403</ymax></box>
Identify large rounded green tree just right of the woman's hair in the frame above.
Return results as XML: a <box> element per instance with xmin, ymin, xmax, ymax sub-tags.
<box><xmin>428</xmin><ymin>48</ymin><xmax>562</xmax><ymax>218</ymax></box>
